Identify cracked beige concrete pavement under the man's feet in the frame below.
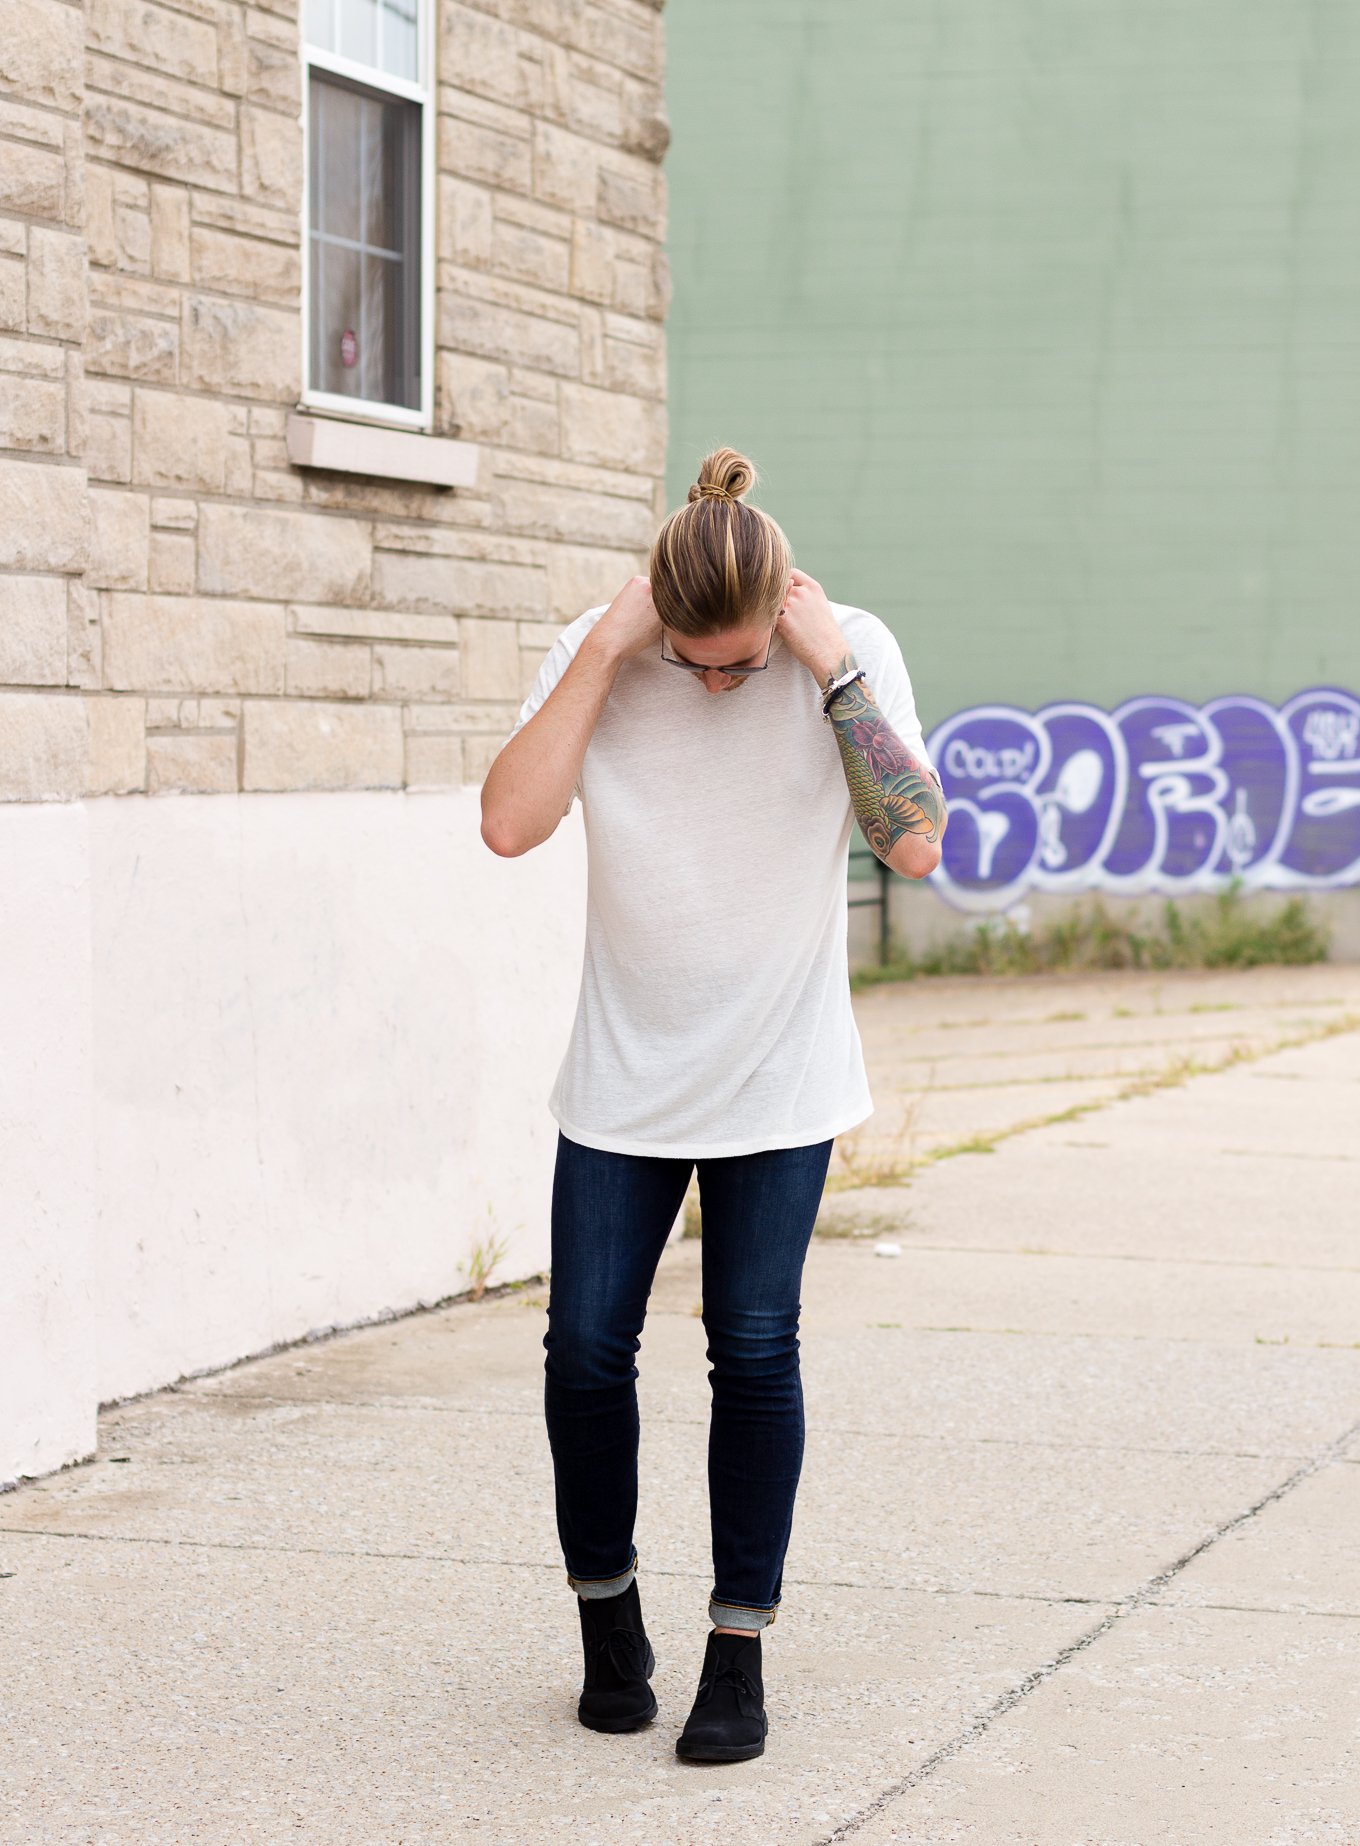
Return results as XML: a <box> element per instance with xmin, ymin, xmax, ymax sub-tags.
<box><xmin>0</xmin><ymin>967</ymin><xmax>1360</xmax><ymax>1846</ymax></box>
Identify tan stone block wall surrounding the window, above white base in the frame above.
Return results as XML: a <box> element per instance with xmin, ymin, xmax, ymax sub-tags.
<box><xmin>0</xmin><ymin>0</ymin><xmax>668</xmax><ymax>801</ymax></box>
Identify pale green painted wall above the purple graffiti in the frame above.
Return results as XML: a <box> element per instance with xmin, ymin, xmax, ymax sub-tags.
<box><xmin>666</xmin><ymin>0</ymin><xmax>1360</xmax><ymax>727</ymax></box>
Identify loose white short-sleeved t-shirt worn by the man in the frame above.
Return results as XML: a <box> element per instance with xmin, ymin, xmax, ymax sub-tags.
<box><xmin>511</xmin><ymin>602</ymin><xmax>930</xmax><ymax>1159</ymax></box>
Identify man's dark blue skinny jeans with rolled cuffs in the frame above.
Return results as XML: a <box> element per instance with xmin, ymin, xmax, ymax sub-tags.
<box><xmin>543</xmin><ymin>1132</ymin><xmax>832</xmax><ymax>1628</ymax></box>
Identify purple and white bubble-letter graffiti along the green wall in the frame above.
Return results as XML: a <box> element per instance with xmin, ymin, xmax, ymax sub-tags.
<box><xmin>926</xmin><ymin>687</ymin><xmax>1360</xmax><ymax>912</ymax></box>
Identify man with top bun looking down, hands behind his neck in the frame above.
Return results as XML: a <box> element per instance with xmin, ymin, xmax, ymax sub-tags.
<box><xmin>482</xmin><ymin>449</ymin><xmax>945</xmax><ymax>1761</ymax></box>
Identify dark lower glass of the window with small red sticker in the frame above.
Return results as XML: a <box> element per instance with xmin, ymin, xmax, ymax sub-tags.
<box><xmin>308</xmin><ymin>72</ymin><xmax>421</xmax><ymax>410</ymax></box>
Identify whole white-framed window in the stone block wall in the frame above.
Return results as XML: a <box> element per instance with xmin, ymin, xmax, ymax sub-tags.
<box><xmin>303</xmin><ymin>0</ymin><xmax>434</xmax><ymax>428</ymax></box>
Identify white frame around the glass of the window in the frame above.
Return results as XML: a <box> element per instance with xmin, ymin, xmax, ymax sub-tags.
<box><xmin>297</xmin><ymin>0</ymin><xmax>435</xmax><ymax>430</ymax></box>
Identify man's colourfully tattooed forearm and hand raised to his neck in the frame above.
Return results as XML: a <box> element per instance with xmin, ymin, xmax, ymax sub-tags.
<box><xmin>779</xmin><ymin>570</ymin><xmax>948</xmax><ymax>879</ymax></box>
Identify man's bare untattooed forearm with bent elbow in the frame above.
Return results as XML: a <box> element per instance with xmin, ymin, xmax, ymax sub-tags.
<box><xmin>482</xmin><ymin>628</ymin><xmax>622</xmax><ymax>857</ymax></box>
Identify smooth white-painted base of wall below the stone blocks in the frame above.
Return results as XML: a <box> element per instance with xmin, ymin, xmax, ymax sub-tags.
<box><xmin>0</xmin><ymin>788</ymin><xmax>585</xmax><ymax>1482</ymax></box>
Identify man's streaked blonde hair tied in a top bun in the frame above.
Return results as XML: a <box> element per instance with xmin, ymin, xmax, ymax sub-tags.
<box><xmin>648</xmin><ymin>449</ymin><xmax>793</xmax><ymax>635</ymax></box>
